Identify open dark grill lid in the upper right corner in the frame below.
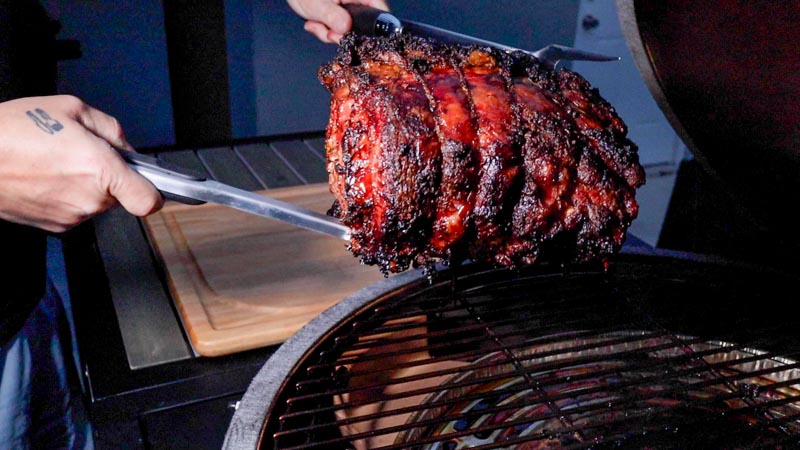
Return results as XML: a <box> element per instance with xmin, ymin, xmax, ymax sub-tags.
<box><xmin>617</xmin><ymin>0</ymin><xmax>800</xmax><ymax>245</ymax></box>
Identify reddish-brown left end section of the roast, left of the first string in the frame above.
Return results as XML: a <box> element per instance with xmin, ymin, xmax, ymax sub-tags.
<box><xmin>321</xmin><ymin>40</ymin><xmax>441</xmax><ymax>272</ymax></box>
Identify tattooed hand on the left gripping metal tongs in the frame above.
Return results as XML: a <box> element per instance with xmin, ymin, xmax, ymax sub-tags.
<box><xmin>0</xmin><ymin>95</ymin><xmax>164</xmax><ymax>232</ymax></box>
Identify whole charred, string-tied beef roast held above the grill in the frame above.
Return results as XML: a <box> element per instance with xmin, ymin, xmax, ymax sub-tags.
<box><xmin>319</xmin><ymin>34</ymin><xmax>644</xmax><ymax>272</ymax></box>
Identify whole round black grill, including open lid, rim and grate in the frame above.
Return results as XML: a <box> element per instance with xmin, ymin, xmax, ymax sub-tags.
<box><xmin>226</xmin><ymin>1</ymin><xmax>800</xmax><ymax>450</ymax></box>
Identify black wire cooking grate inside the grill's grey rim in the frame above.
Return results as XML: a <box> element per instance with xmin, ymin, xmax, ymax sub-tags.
<box><xmin>272</xmin><ymin>268</ymin><xmax>800</xmax><ymax>450</ymax></box>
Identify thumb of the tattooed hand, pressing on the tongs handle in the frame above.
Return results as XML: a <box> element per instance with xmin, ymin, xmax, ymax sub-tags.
<box><xmin>106</xmin><ymin>152</ymin><xmax>164</xmax><ymax>217</ymax></box>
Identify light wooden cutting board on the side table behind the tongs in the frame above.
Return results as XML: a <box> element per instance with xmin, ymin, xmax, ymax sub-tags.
<box><xmin>144</xmin><ymin>184</ymin><xmax>383</xmax><ymax>356</ymax></box>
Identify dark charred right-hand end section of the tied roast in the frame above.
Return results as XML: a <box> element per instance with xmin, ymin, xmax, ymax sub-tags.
<box><xmin>508</xmin><ymin>54</ymin><xmax>644</xmax><ymax>263</ymax></box>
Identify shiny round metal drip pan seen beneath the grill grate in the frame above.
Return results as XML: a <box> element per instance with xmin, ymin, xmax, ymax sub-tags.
<box><xmin>390</xmin><ymin>332</ymin><xmax>800</xmax><ymax>449</ymax></box>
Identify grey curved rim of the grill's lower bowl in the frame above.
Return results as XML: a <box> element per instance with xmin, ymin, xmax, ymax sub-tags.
<box><xmin>223</xmin><ymin>247</ymin><xmax>787</xmax><ymax>450</ymax></box>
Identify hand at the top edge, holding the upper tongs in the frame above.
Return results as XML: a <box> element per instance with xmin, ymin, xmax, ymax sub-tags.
<box><xmin>286</xmin><ymin>0</ymin><xmax>389</xmax><ymax>44</ymax></box>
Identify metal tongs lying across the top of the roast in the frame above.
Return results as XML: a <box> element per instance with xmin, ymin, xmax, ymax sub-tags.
<box><xmin>342</xmin><ymin>4</ymin><xmax>619</xmax><ymax>69</ymax></box>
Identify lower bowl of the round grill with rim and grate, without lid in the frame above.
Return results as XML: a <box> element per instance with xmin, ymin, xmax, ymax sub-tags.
<box><xmin>226</xmin><ymin>255</ymin><xmax>800</xmax><ymax>450</ymax></box>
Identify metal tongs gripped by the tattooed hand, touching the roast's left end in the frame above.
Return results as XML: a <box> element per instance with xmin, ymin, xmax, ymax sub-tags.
<box><xmin>118</xmin><ymin>150</ymin><xmax>350</xmax><ymax>240</ymax></box>
